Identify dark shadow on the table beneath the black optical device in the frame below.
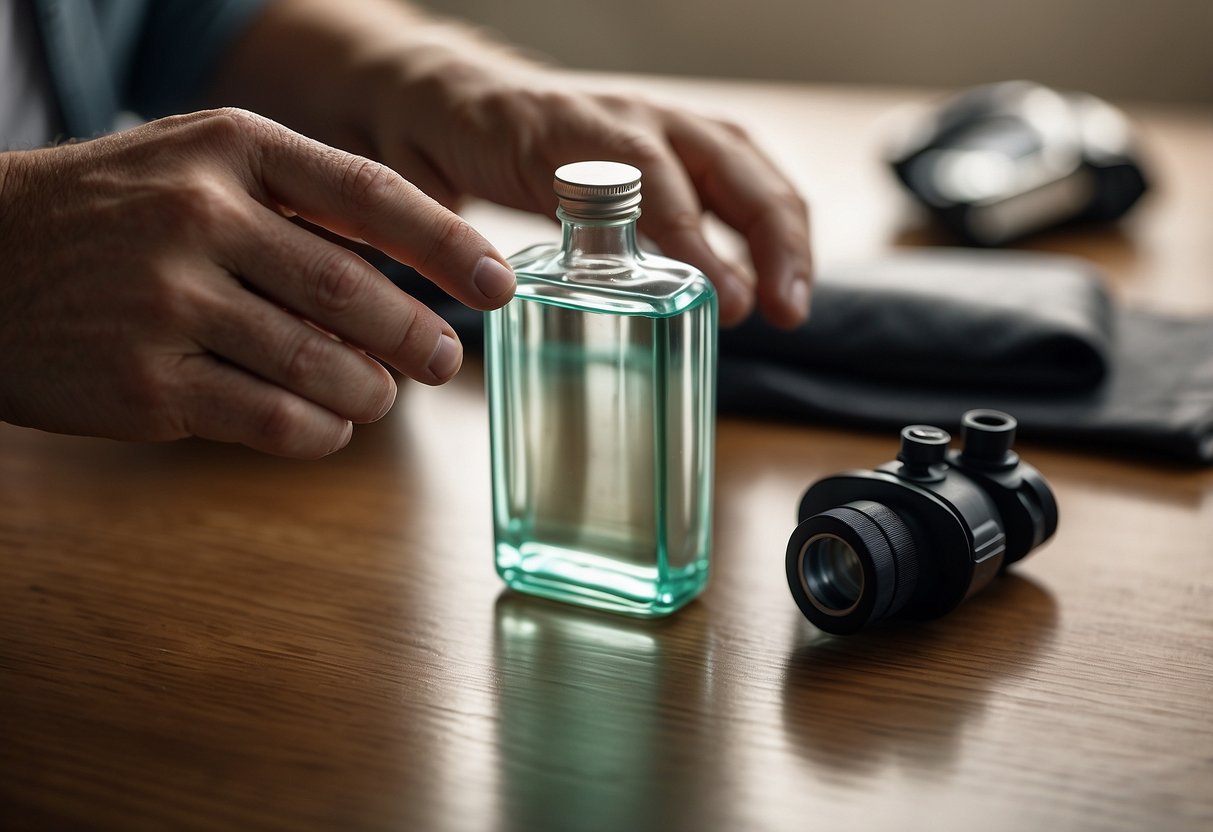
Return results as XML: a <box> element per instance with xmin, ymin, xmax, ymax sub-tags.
<box><xmin>784</xmin><ymin>575</ymin><xmax>1058</xmax><ymax>781</ymax></box>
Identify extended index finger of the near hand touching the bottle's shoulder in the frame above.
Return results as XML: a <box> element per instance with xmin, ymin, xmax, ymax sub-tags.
<box><xmin>243</xmin><ymin>117</ymin><xmax>514</xmax><ymax>309</ymax></box>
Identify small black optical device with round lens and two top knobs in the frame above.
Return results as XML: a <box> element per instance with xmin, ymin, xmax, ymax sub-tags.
<box><xmin>786</xmin><ymin>410</ymin><xmax>1058</xmax><ymax>634</ymax></box>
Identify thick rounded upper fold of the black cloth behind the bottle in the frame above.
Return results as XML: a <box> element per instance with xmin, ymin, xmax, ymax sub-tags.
<box><xmin>721</xmin><ymin>249</ymin><xmax>1114</xmax><ymax>391</ymax></box>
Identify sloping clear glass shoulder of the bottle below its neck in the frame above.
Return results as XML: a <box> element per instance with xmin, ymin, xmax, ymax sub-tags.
<box><xmin>509</xmin><ymin>245</ymin><xmax>716</xmax><ymax>317</ymax></box>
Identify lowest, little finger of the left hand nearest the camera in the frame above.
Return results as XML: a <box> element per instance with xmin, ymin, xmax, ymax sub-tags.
<box><xmin>175</xmin><ymin>354</ymin><xmax>353</xmax><ymax>460</ymax></box>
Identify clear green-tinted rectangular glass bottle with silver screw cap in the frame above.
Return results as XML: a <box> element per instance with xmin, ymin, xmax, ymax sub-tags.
<box><xmin>485</xmin><ymin>161</ymin><xmax>717</xmax><ymax>616</ymax></box>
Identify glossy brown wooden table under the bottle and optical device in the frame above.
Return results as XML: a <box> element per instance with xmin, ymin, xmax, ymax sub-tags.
<box><xmin>0</xmin><ymin>80</ymin><xmax>1213</xmax><ymax>832</ymax></box>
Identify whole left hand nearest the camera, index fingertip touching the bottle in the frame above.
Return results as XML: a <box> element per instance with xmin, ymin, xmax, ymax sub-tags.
<box><xmin>0</xmin><ymin>110</ymin><xmax>513</xmax><ymax>457</ymax></box>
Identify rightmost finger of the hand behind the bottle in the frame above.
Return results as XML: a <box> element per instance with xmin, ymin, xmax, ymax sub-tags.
<box><xmin>668</xmin><ymin>113</ymin><xmax>813</xmax><ymax>327</ymax></box>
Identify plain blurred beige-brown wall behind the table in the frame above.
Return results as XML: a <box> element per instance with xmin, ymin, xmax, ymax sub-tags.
<box><xmin>421</xmin><ymin>0</ymin><xmax>1213</xmax><ymax>103</ymax></box>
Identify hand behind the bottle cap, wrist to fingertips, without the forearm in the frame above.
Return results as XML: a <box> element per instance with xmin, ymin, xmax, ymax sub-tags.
<box><xmin>376</xmin><ymin>56</ymin><xmax>811</xmax><ymax>327</ymax></box>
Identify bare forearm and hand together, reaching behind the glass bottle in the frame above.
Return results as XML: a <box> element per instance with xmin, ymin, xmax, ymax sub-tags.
<box><xmin>211</xmin><ymin>0</ymin><xmax>813</xmax><ymax>326</ymax></box>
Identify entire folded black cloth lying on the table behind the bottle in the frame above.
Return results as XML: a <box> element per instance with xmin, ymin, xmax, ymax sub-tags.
<box><xmin>383</xmin><ymin>249</ymin><xmax>1213</xmax><ymax>465</ymax></box>
